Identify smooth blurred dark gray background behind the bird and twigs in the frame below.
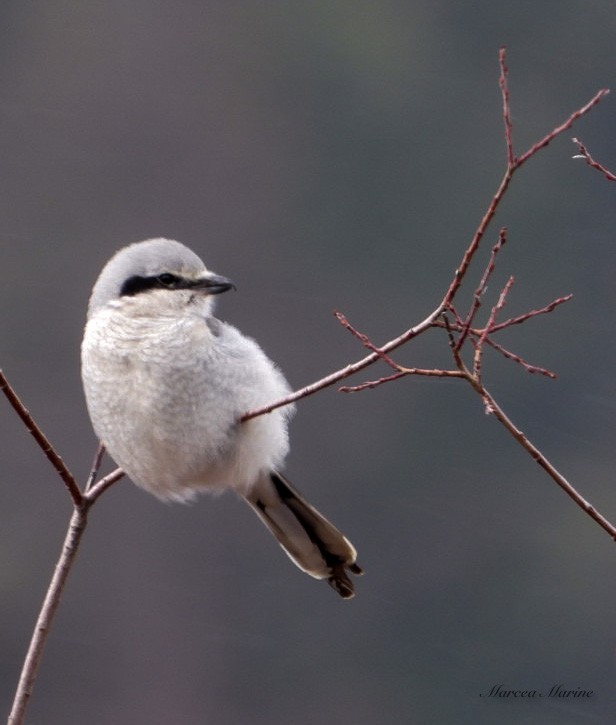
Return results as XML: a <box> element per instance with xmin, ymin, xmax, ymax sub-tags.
<box><xmin>0</xmin><ymin>0</ymin><xmax>616</xmax><ymax>725</ymax></box>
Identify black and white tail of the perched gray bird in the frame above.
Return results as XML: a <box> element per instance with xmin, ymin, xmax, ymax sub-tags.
<box><xmin>246</xmin><ymin>471</ymin><xmax>363</xmax><ymax>599</ymax></box>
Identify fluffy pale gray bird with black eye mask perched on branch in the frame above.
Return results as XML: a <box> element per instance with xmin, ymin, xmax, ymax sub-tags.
<box><xmin>81</xmin><ymin>238</ymin><xmax>363</xmax><ymax>599</ymax></box>
